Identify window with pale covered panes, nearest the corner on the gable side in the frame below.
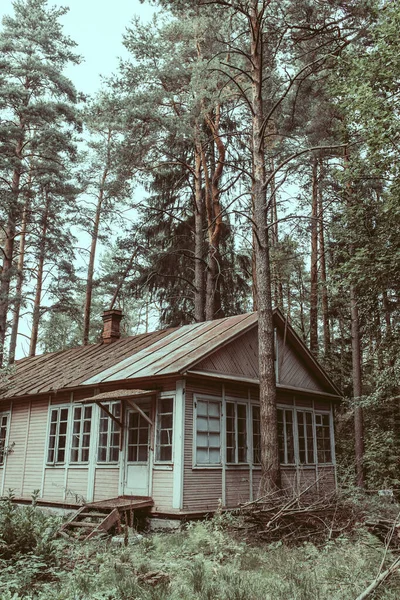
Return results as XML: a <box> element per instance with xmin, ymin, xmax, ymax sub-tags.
<box><xmin>196</xmin><ymin>400</ymin><xmax>221</xmax><ymax>465</ymax></box>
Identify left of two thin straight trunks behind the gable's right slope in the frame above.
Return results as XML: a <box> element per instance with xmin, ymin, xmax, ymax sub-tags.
<box><xmin>310</xmin><ymin>158</ymin><xmax>318</xmax><ymax>354</ymax></box>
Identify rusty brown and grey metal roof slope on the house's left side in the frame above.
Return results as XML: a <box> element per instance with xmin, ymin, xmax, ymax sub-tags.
<box><xmin>1</xmin><ymin>313</ymin><xmax>257</xmax><ymax>398</ymax></box>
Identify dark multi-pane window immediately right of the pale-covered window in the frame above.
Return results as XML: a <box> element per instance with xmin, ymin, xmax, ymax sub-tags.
<box><xmin>226</xmin><ymin>402</ymin><xmax>247</xmax><ymax>463</ymax></box>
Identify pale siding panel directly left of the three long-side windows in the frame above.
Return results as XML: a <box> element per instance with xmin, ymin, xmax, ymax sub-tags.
<box><xmin>22</xmin><ymin>399</ymin><xmax>48</xmax><ymax>497</ymax></box>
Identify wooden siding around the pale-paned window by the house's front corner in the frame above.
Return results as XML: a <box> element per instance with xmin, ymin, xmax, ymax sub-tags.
<box><xmin>183</xmin><ymin>381</ymin><xmax>222</xmax><ymax>511</ymax></box>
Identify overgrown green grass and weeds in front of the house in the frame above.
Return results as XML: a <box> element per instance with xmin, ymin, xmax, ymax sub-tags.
<box><xmin>0</xmin><ymin>504</ymin><xmax>400</xmax><ymax>600</ymax></box>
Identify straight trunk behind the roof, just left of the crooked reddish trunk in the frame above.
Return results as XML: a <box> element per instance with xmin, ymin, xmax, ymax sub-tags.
<box><xmin>194</xmin><ymin>144</ymin><xmax>205</xmax><ymax>322</ymax></box>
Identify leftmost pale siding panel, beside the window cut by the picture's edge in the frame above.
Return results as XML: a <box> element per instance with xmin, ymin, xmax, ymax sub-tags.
<box><xmin>4</xmin><ymin>402</ymin><xmax>29</xmax><ymax>496</ymax></box>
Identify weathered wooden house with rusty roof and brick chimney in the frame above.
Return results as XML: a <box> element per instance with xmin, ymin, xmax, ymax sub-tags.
<box><xmin>0</xmin><ymin>310</ymin><xmax>339</xmax><ymax>515</ymax></box>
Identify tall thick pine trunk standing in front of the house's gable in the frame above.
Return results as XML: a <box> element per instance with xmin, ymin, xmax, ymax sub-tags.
<box><xmin>249</xmin><ymin>0</ymin><xmax>281</xmax><ymax>491</ymax></box>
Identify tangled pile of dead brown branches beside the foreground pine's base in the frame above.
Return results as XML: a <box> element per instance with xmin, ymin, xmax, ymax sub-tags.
<box><xmin>240</xmin><ymin>494</ymin><xmax>362</xmax><ymax>545</ymax></box>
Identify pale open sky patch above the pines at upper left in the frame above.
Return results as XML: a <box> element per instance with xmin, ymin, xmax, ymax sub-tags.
<box><xmin>0</xmin><ymin>0</ymin><xmax>154</xmax><ymax>94</ymax></box>
